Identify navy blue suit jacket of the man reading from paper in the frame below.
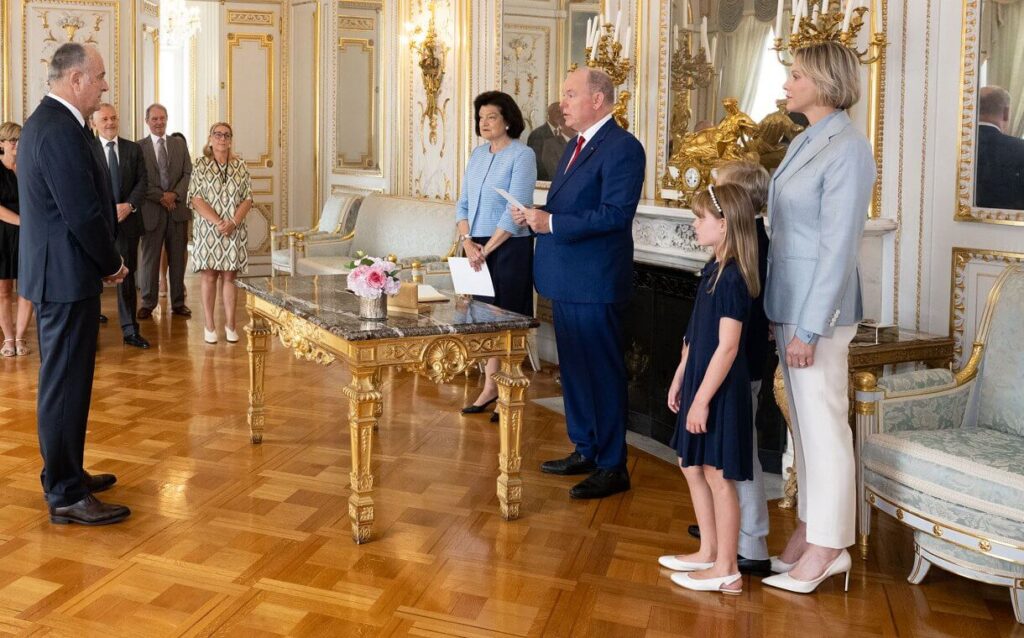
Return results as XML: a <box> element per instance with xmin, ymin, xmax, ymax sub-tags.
<box><xmin>534</xmin><ymin>119</ymin><xmax>646</xmax><ymax>303</ymax></box>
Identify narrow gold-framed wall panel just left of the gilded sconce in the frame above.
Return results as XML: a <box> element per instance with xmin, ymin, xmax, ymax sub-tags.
<box><xmin>333</xmin><ymin>1</ymin><xmax>382</xmax><ymax>174</ymax></box>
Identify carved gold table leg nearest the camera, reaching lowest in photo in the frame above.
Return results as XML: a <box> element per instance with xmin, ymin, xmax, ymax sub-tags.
<box><xmin>344</xmin><ymin>366</ymin><xmax>383</xmax><ymax>543</ymax></box>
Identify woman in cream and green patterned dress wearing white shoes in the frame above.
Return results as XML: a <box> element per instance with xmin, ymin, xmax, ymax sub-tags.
<box><xmin>188</xmin><ymin>122</ymin><xmax>253</xmax><ymax>343</ymax></box>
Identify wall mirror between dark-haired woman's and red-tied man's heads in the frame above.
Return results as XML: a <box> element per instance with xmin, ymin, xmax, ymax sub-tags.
<box><xmin>502</xmin><ymin>0</ymin><xmax>601</xmax><ymax>181</ymax></box>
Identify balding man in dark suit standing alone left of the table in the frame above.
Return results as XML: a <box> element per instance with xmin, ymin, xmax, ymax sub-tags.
<box><xmin>17</xmin><ymin>42</ymin><xmax>131</xmax><ymax>525</ymax></box>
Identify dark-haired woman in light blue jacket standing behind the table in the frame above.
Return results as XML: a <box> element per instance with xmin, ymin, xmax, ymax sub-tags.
<box><xmin>455</xmin><ymin>91</ymin><xmax>537</xmax><ymax>421</ymax></box>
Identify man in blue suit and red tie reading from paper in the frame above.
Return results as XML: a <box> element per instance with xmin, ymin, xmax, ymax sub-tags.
<box><xmin>515</xmin><ymin>69</ymin><xmax>645</xmax><ymax>499</ymax></box>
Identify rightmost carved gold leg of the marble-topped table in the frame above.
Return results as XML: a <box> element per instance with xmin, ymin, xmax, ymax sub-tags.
<box><xmin>495</xmin><ymin>353</ymin><xmax>529</xmax><ymax>520</ymax></box>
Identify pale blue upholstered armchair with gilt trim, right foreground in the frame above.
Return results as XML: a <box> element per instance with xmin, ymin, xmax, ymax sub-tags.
<box><xmin>855</xmin><ymin>266</ymin><xmax>1024</xmax><ymax>624</ymax></box>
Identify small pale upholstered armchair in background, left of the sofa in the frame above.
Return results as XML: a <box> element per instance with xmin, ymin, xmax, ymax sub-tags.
<box><xmin>270</xmin><ymin>194</ymin><xmax>362</xmax><ymax>274</ymax></box>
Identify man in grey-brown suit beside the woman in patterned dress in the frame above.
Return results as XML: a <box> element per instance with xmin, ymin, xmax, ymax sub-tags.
<box><xmin>138</xmin><ymin>104</ymin><xmax>191</xmax><ymax>318</ymax></box>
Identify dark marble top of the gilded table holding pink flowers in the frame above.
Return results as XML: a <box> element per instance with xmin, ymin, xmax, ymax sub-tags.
<box><xmin>234</xmin><ymin>274</ymin><xmax>540</xmax><ymax>341</ymax></box>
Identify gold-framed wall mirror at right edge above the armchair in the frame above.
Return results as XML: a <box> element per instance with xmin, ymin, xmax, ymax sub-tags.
<box><xmin>956</xmin><ymin>0</ymin><xmax>1024</xmax><ymax>225</ymax></box>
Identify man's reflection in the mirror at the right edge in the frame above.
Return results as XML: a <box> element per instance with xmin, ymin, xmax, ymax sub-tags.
<box><xmin>974</xmin><ymin>86</ymin><xmax>1024</xmax><ymax>210</ymax></box>
